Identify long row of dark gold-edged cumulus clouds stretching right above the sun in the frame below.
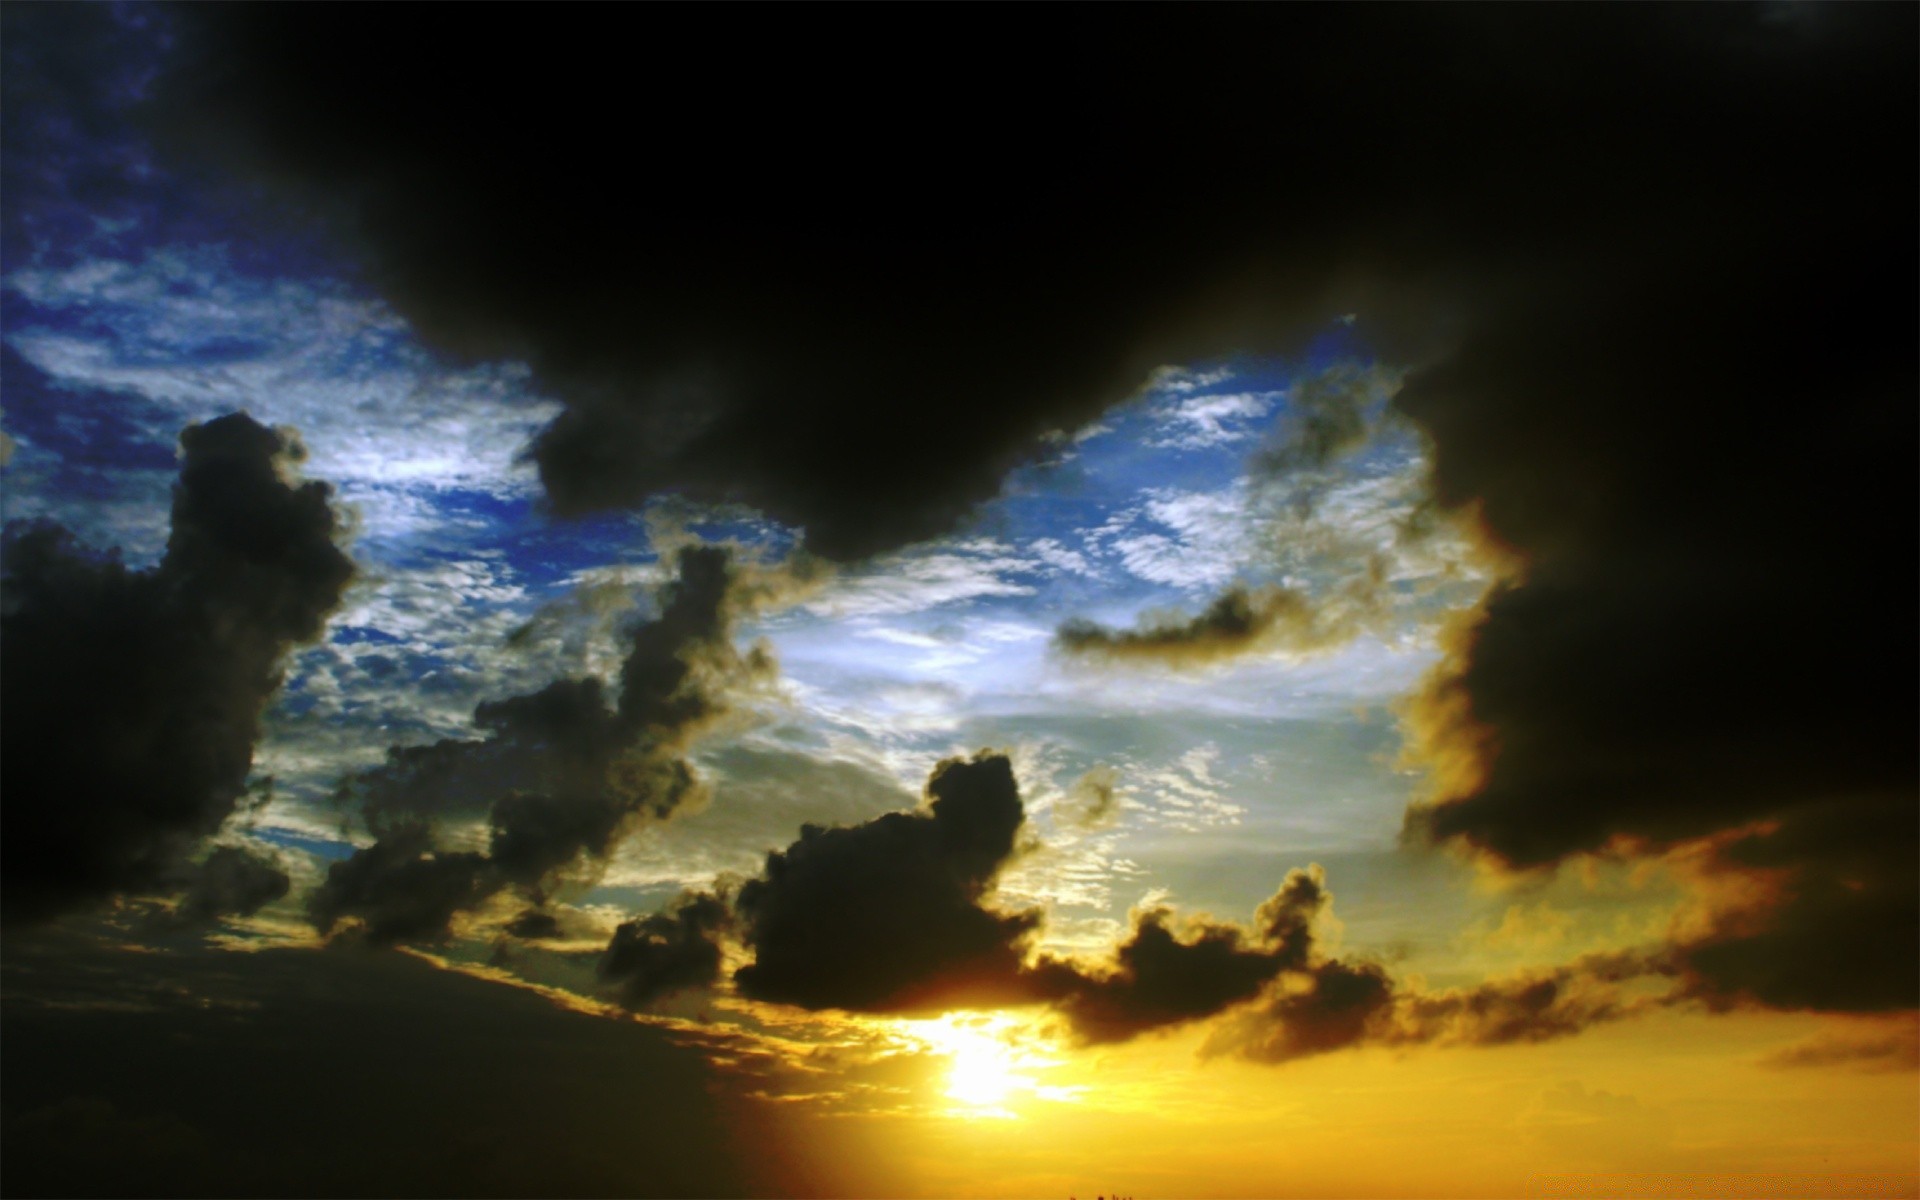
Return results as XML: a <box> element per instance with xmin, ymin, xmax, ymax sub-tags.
<box><xmin>599</xmin><ymin>751</ymin><xmax>1690</xmax><ymax>1062</ymax></box>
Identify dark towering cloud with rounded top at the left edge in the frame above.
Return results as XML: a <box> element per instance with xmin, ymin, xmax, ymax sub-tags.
<box><xmin>0</xmin><ymin>415</ymin><xmax>353</xmax><ymax>920</ymax></box>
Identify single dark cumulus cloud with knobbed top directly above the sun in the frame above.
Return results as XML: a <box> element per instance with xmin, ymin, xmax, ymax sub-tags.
<box><xmin>733</xmin><ymin>753</ymin><xmax>1039</xmax><ymax>1012</ymax></box>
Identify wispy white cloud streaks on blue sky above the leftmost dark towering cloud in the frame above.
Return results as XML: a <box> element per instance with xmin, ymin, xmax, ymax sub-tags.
<box><xmin>4</xmin><ymin>248</ymin><xmax>559</xmax><ymax>538</ymax></box>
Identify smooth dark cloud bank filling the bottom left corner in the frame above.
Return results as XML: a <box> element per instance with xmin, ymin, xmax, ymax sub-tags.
<box><xmin>0</xmin><ymin>929</ymin><xmax>764</xmax><ymax>1196</ymax></box>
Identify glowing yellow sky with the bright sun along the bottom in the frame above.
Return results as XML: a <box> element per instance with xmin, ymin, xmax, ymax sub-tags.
<box><xmin>752</xmin><ymin>1014</ymin><xmax>1920</xmax><ymax>1198</ymax></box>
